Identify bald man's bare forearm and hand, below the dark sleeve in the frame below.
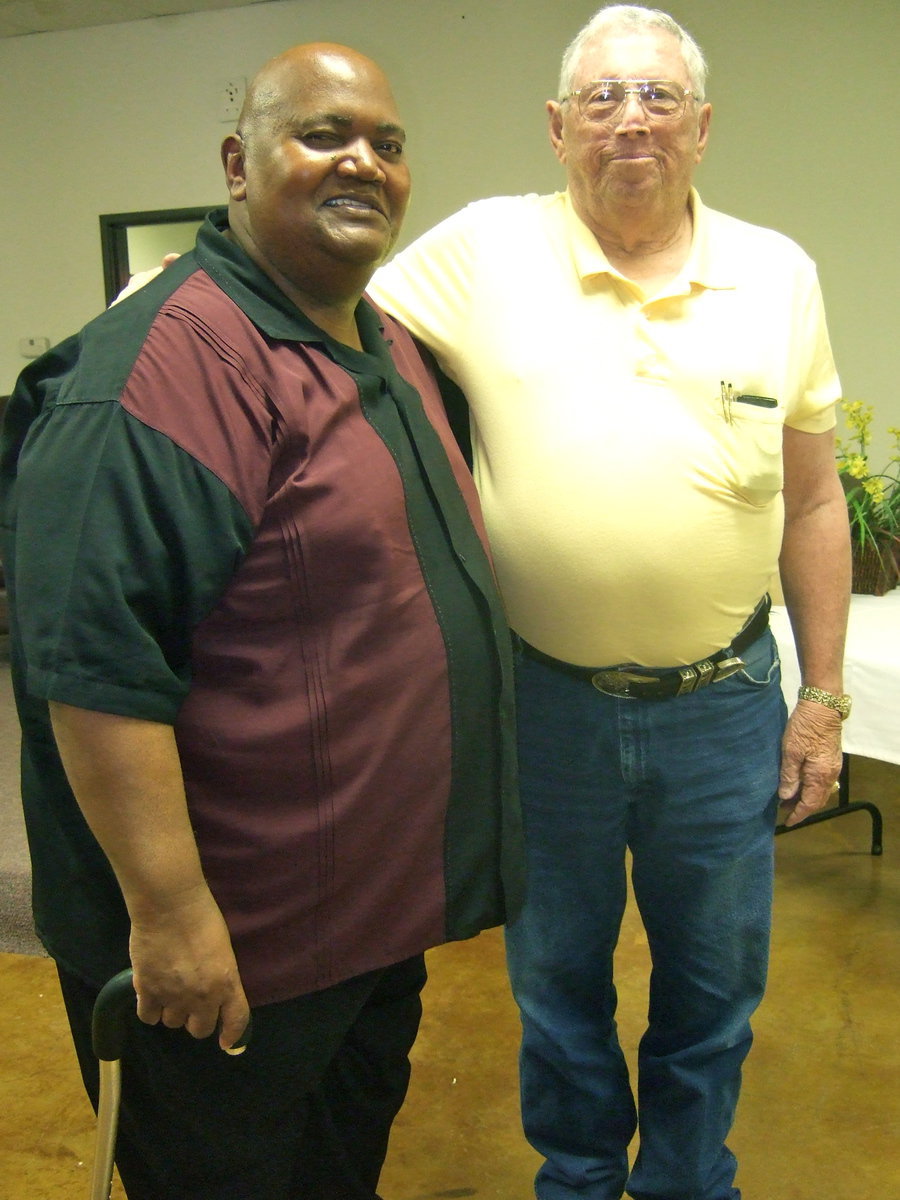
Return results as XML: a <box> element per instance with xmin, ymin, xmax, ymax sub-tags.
<box><xmin>50</xmin><ymin>703</ymin><xmax>248</xmax><ymax>1050</ymax></box>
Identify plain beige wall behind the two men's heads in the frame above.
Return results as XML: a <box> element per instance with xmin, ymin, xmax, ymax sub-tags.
<box><xmin>0</xmin><ymin>0</ymin><xmax>900</xmax><ymax>463</ymax></box>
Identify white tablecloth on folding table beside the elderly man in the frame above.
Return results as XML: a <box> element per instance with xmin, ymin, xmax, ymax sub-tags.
<box><xmin>770</xmin><ymin>588</ymin><xmax>900</xmax><ymax>763</ymax></box>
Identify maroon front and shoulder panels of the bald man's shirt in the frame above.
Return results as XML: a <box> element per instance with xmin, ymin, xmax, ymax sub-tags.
<box><xmin>122</xmin><ymin>272</ymin><xmax>458</xmax><ymax>1004</ymax></box>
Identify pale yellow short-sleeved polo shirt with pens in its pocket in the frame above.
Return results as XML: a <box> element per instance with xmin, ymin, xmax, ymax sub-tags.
<box><xmin>379</xmin><ymin>193</ymin><xmax>840</xmax><ymax>666</ymax></box>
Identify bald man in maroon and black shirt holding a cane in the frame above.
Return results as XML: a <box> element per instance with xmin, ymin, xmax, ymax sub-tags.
<box><xmin>0</xmin><ymin>44</ymin><xmax>522</xmax><ymax>1200</ymax></box>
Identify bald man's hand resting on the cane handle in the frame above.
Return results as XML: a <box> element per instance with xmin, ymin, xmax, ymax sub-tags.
<box><xmin>131</xmin><ymin>887</ymin><xmax>250</xmax><ymax>1050</ymax></box>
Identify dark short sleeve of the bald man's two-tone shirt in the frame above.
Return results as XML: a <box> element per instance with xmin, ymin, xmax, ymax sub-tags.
<box><xmin>14</xmin><ymin>352</ymin><xmax>252</xmax><ymax>724</ymax></box>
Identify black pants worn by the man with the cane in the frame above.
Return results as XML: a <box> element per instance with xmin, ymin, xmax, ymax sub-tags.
<box><xmin>59</xmin><ymin>955</ymin><xmax>425</xmax><ymax>1200</ymax></box>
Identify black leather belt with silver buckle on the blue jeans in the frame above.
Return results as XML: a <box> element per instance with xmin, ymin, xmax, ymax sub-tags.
<box><xmin>518</xmin><ymin>595</ymin><xmax>772</xmax><ymax>700</ymax></box>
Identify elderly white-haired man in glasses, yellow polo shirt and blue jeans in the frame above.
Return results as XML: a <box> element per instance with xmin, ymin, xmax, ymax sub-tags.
<box><xmin>371</xmin><ymin>6</ymin><xmax>850</xmax><ymax>1200</ymax></box>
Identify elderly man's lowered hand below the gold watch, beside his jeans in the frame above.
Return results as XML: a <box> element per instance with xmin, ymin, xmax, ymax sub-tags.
<box><xmin>778</xmin><ymin>700</ymin><xmax>842</xmax><ymax>826</ymax></box>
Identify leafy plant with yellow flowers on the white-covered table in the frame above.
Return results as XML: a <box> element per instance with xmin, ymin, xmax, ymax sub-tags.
<box><xmin>838</xmin><ymin>400</ymin><xmax>900</xmax><ymax>558</ymax></box>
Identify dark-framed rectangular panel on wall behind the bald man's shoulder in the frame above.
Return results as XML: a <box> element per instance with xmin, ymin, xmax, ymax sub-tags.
<box><xmin>100</xmin><ymin>204</ymin><xmax>217</xmax><ymax>305</ymax></box>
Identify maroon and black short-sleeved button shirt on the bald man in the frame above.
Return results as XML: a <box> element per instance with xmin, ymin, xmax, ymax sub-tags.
<box><xmin>0</xmin><ymin>212</ymin><xmax>522</xmax><ymax>1004</ymax></box>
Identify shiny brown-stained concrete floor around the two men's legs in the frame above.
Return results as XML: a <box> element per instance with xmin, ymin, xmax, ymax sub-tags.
<box><xmin>0</xmin><ymin>758</ymin><xmax>900</xmax><ymax>1200</ymax></box>
